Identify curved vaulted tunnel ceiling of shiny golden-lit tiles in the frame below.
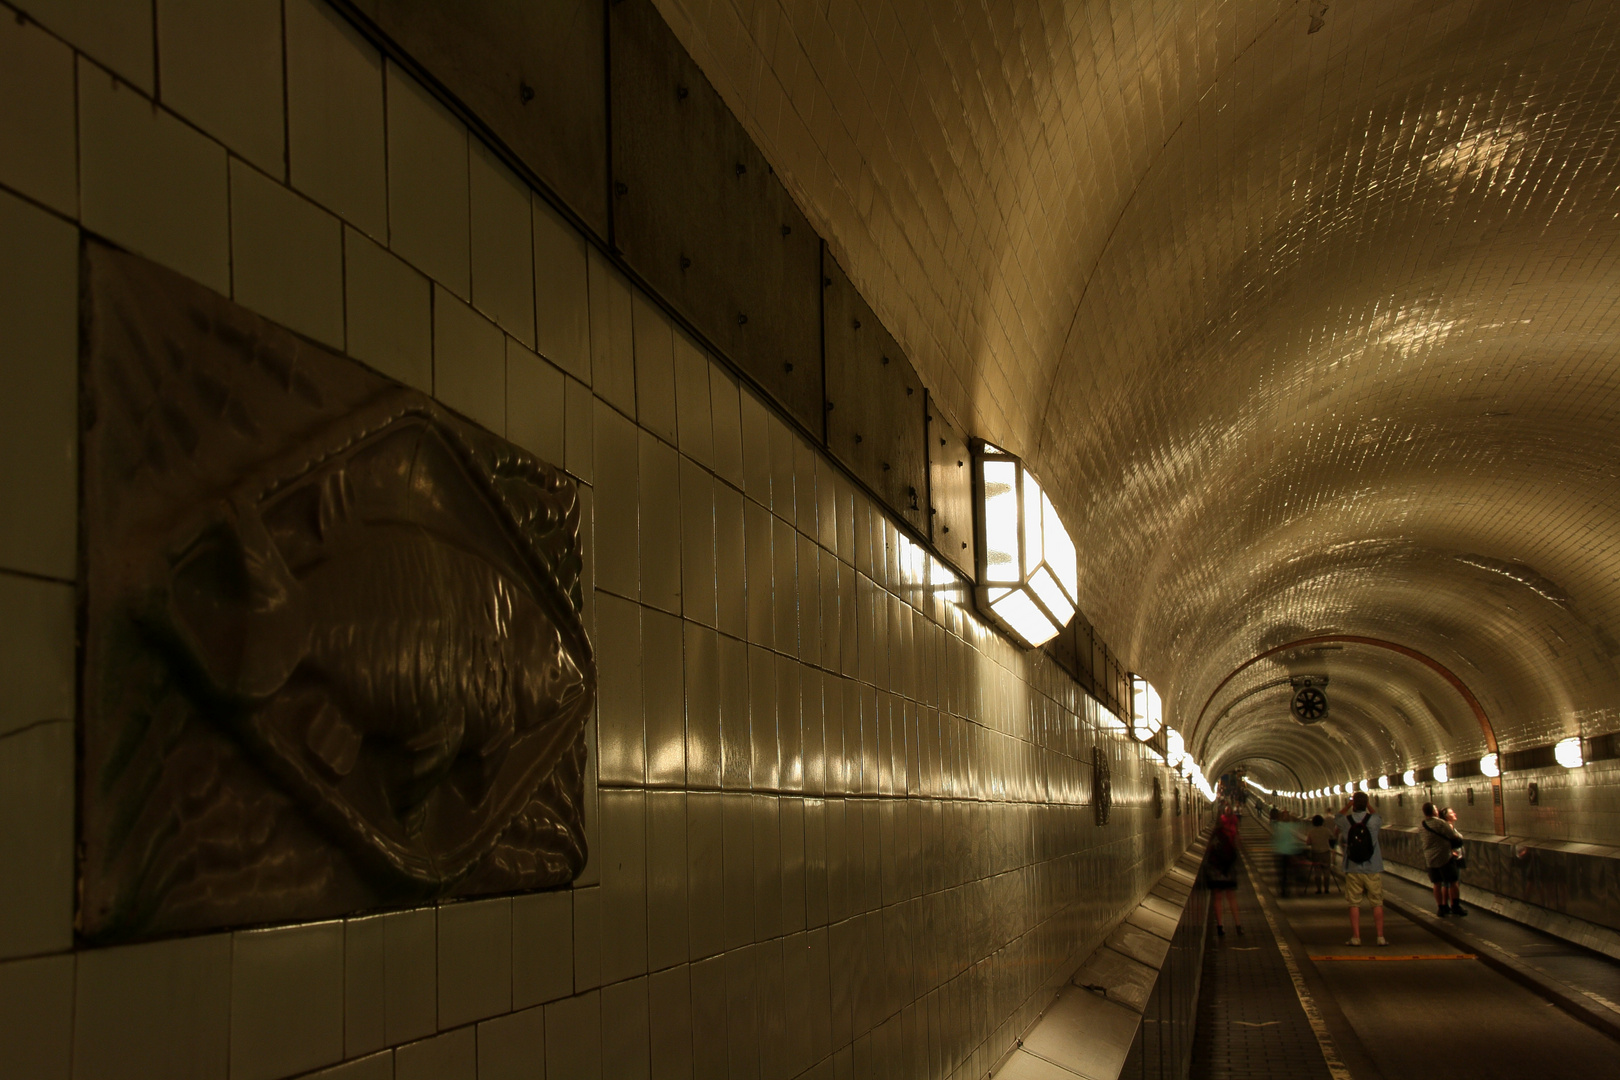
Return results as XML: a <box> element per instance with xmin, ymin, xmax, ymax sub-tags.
<box><xmin>658</xmin><ymin>0</ymin><xmax>1620</xmax><ymax>784</ymax></box>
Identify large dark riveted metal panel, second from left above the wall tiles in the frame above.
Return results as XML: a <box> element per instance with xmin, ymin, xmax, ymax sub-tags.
<box><xmin>609</xmin><ymin>0</ymin><xmax>821</xmax><ymax>436</ymax></box>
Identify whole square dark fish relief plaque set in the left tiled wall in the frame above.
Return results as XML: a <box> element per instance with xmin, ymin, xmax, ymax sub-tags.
<box><xmin>79</xmin><ymin>241</ymin><xmax>596</xmax><ymax>941</ymax></box>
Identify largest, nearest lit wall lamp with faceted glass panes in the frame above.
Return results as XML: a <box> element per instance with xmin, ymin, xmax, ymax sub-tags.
<box><xmin>974</xmin><ymin>442</ymin><xmax>1079</xmax><ymax>648</ymax></box>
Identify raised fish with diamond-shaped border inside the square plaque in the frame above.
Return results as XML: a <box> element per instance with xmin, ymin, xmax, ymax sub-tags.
<box><xmin>152</xmin><ymin>398</ymin><xmax>595</xmax><ymax>894</ymax></box>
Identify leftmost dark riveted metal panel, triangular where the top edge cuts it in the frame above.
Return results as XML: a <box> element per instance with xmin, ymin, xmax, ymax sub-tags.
<box><xmin>340</xmin><ymin>0</ymin><xmax>608</xmax><ymax>238</ymax></box>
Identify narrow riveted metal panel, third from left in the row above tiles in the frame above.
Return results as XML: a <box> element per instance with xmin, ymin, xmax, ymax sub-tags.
<box><xmin>821</xmin><ymin>253</ymin><xmax>933</xmax><ymax>531</ymax></box>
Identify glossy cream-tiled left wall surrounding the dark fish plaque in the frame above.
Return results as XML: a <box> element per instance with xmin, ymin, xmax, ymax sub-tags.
<box><xmin>0</xmin><ymin>0</ymin><xmax>1199</xmax><ymax>1080</ymax></box>
